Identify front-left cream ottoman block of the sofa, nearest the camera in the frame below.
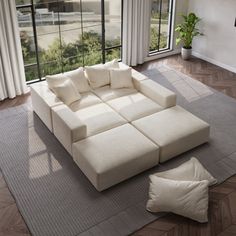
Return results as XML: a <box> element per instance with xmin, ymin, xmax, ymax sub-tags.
<box><xmin>72</xmin><ymin>124</ymin><xmax>159</xmax><ymax>191</ymax></box>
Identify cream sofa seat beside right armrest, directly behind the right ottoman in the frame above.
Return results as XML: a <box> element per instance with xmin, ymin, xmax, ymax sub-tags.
<box><xmin>107</xmin><ymin>93</ymin><xmax>163</xmax><ymax>122</ymax></box>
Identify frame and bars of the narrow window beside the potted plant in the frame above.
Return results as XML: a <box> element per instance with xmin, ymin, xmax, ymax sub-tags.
<box><xmin>148</xmin><ymin>0</ymin><xmax>174</xmax><ymax>56</ymax></box>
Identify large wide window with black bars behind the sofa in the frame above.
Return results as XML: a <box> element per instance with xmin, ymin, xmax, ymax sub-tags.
<box><xmin>15</xmin><ymin>0</ymin><xmax>122</xmax><ymax>82</ymax></box>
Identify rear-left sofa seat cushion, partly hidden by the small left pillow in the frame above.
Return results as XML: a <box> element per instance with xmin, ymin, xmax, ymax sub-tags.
<box><xmin>69</xmin><ymin>92</ymin><xmax>102</xmax><ymax>112</ymax></box>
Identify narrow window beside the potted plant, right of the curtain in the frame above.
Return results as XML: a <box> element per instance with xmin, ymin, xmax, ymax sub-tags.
<box><xmin>149</xmin><ymin>0</ymin><xmax>173</xmax><ymax>54</ymax></box>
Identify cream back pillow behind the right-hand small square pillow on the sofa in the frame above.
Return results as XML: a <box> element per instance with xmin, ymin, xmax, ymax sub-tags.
<box><xmin>85</xmin><ymin>59</ymin><xmax>119</xmax><ymax>89</ymax></box>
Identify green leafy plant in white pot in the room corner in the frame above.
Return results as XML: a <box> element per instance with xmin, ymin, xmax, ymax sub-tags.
<box><xmin>175</xmin><ymin>12</ymin><xmax>202</xmax><ymax>60</ymax></box>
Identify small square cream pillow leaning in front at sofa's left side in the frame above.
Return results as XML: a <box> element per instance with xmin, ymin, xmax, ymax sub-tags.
<box><xmin>53</xmin><ymin>79</ymin><xmax>81</xmax><ymax>105</ymax></box>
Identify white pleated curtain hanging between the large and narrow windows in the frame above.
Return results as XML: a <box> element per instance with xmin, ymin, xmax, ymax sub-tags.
<box><xmin>122</xmin><ymin>0</ymin><xmax>151</xmax><ymax>66</ymax></box>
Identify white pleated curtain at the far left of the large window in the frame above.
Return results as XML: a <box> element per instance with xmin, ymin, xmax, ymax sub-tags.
<box><xmin>0</xmin><ymin>0</ymin><xmax>28</xmax><ymax>101</ymax></box>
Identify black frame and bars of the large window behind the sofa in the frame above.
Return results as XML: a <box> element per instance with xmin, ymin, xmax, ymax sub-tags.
<box><xmin>16</xmin><ymin>0</ymin><xmax>123</xmax><ymax>84</ymax></box>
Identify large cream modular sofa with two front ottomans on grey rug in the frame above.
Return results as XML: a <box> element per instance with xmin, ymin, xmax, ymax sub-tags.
<box><xmin>31</xmin><ymin>61</ymin><xmax>210</xmax><ymax>191</ymax></box>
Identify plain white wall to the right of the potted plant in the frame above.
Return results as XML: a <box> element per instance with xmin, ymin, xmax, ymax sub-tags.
<box><xmin>188</xmin><ymin>0</ymin><xmax>236</xmax><ymax>72</ymax></box>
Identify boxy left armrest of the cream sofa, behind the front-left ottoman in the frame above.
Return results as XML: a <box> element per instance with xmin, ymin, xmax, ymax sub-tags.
<box><xmin>52</xmin><ymin>105</ymin><xmax>87</xmax><ymax>154</ymax></box>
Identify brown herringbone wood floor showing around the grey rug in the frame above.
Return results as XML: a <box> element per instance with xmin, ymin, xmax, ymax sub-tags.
<box><xmin>0</xmin><ymin>55</ymin><xmax>236</xmax><ymax>236</ymax></box>
